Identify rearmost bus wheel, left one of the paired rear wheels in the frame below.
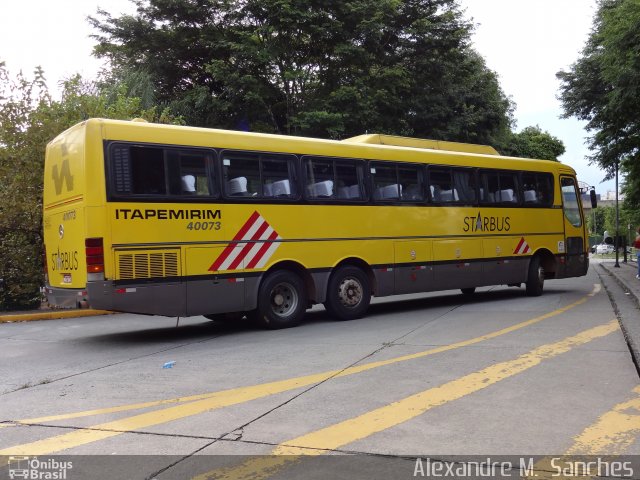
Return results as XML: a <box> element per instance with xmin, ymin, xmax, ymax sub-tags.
<box><xmin>251</xmin><ymin>270</ymin><xmax>307</xmax><ymax>330</ymax></box>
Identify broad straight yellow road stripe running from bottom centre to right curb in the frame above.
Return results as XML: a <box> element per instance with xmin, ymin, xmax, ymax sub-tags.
<box><xmin>195</xmin><ymin>320</ymin><xmax>619</xmax><ymax>480</ymax></box>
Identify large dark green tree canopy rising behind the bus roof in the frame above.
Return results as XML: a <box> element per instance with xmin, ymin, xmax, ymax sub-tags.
<box><xmin>91</xmin><ymin>0</ymin><xmax>512</xmax><ymax>145</ymax></box>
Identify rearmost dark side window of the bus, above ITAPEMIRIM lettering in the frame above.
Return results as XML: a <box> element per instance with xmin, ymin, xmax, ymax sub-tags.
<box><xmin>108</xmin><ymin>143</ymin><xmax>217</xmax><ymax>198</ymax></box>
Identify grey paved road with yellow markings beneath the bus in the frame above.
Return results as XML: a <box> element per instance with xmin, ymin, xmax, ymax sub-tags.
<box><xmin>0</xmin><ymin>269</ymin><xmax>640</xmax><ymax>479</ymax></box>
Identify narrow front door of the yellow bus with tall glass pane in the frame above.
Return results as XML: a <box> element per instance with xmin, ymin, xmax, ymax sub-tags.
<box><xmin>558</xmin><ymin>176</ymin><xmax>588</xmax><ymax>277</ymax></box>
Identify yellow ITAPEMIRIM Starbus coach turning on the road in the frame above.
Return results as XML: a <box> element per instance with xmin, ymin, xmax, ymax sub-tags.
<box><xmin>43</xmin><ymin>119</ymin><xmax>589</xmax><ymax>328</ymax></box>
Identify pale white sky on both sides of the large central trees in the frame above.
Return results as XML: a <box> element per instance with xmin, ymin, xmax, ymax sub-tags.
<box><xmin>0</xmin><ymin>0</ymin><xmax>614</xmax><ymax>194</ymax></box>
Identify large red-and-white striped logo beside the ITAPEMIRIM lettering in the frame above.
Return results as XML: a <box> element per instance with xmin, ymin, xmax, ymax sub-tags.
<box><xmin>209</xmin><ymin>211</ymin><xmax>282</xmax><ymax>272</ymax></box>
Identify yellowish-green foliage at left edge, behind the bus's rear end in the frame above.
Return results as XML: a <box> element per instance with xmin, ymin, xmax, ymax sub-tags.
<box><xmin>0</xmin><ymin>62</ymin><xmax>180</xmax><ymax>310</ymax></box>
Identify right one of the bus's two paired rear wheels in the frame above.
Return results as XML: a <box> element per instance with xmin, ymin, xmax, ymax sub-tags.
<box><xmin>324</xmin><ymin>265</ymin><xmax>371</xmax><ymax>320</ymax></box>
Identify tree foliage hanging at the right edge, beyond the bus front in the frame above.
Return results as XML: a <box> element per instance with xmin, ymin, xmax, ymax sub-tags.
<box><xmin>557</xmin><ymin>0</ymin><xmax>640</xmax><ymax>208</ymax></box>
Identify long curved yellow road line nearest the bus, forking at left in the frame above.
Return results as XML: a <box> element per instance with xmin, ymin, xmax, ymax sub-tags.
<box><xmin>0</xmin><ymin>284</ymin><xmax>599</xmax><ymax>455</ymax></box>
